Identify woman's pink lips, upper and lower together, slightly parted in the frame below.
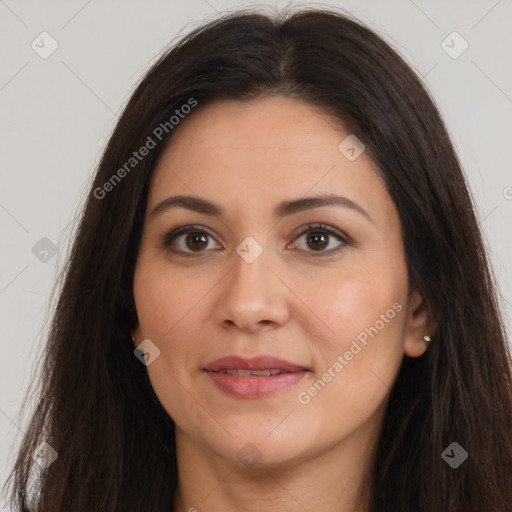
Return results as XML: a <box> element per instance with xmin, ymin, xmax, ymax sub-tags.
<box><xmin>204</xmin><ymin>356</ymin><xmax>309</xmax><ymax>398</ymax></box>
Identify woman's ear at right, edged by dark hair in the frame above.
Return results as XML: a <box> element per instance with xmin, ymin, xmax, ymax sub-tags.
<box><xmin>404</xmin><ymin>290</ymin><xmax>437</xmax><ymax>357</ymax></box>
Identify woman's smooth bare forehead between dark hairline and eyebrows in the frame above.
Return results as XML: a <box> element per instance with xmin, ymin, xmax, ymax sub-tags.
<box><xmin>148</xmin><ymin>96</ymin><xmax>391</xmax><ymax>224</ymax></box>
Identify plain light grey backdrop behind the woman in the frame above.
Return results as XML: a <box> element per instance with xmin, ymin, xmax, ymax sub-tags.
<box><xmin>0</xmin><ymin>0</ymin><xmax>512</xmax><ymax>502</ymax></box>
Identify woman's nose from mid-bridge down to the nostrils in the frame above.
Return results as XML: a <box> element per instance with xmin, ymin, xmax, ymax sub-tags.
<box><xmin>216</xmin><ymin>247</ymin><xmax>290</xmax><ymax>332</ymax></box>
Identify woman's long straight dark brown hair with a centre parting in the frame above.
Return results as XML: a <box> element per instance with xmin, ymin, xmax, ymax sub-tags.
<box><xmin>4</xmin><ymin>8</ymin><xmax>512</xmax><ymax>512</ymax></box>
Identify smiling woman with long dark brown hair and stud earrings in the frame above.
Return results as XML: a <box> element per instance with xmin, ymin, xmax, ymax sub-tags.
<box><xmin>4</xmin><ymin>5</ymin><xmax>512</xmax><ymax>512</ymax></box>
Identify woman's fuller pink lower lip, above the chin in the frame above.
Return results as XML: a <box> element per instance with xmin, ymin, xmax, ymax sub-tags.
<box><xmin>206</xmin><ymin>370</ymin><xmax>308</xmax><ymax>398</ymax></box>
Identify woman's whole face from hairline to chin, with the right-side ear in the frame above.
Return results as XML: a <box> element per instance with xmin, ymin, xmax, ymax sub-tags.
<box><xmin>133</xmin><ymin>96</ymin><xmax>429</xmax><ymax>464</ymax></box>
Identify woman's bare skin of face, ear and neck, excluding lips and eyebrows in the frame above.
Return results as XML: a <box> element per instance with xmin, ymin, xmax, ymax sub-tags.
<box><xmin>133</xmin><ymin>96</ymin><xmax>433</xmax><ymax>512</ymax></box>
